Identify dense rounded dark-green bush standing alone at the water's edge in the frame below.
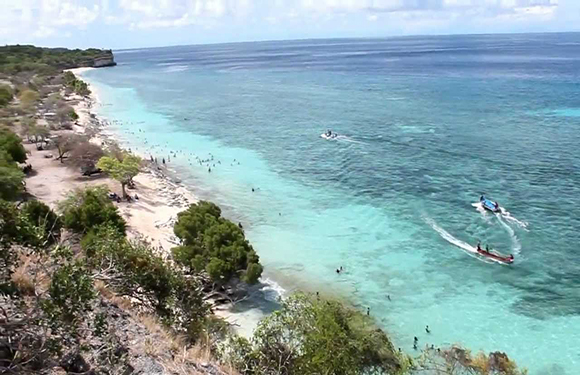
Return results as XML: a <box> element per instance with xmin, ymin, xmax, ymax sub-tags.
<box><xmin>172</xmin><ymin>201</ymin><xmax>262</xmax><ymax>283</ymax></box>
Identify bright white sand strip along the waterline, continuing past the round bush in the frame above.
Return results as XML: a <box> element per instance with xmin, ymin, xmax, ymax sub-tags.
<box><xmin>62</xmin><ymin>68</ymin><xmax>285</xmax><ymax>337</ymax></box>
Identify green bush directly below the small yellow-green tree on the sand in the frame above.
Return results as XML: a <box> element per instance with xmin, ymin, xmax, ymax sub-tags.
<box><xmin>59</xmin><ymin>186</ymin><xmax>126</xmax><ymax>235</ymax></box>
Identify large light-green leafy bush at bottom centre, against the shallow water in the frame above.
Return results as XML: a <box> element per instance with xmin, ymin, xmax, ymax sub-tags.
<box><xmin>221</xmin><ymin>294</ymin><xmax>401</xmax><ymax>375</ymax></box>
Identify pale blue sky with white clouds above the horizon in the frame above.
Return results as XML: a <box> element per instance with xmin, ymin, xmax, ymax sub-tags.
<box><xmin>0</xmin><ymin>0</ymin><xmax>580</xmax><ymax>49</ymax></box>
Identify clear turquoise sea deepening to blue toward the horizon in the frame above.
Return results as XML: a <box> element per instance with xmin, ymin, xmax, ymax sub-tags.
<box><xmin>85</xmin><ymin>34</ymin><xmax>580</xmax><ymax>375</ymax></box>
